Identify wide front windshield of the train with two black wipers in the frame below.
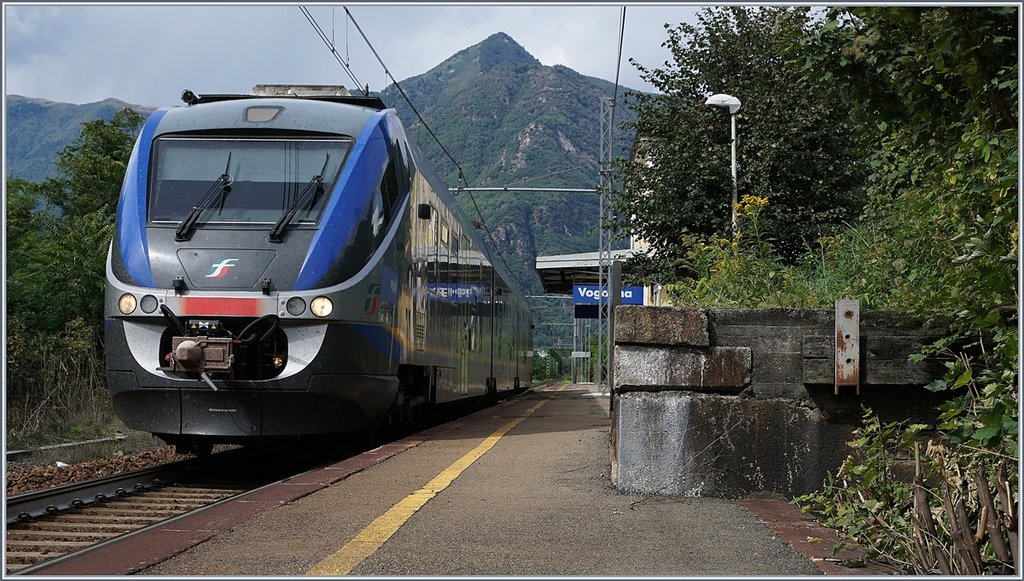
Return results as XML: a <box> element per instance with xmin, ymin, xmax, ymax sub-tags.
<box><xmin>150</xmin><ymin>137</ymin><xmax>352</xmax><ymax>224</ymax></box>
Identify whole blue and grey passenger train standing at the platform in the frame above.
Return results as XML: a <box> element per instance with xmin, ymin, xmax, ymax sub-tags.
<box><xmin>104</xmin><ymin>85</ymin><xmax>532</xmax><ymax>453</ymax></box>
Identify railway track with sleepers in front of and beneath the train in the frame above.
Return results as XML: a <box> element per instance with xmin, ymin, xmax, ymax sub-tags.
<box><xmin>4</xmin><ymin>449</ymin><xmax>319</xmax><ymax>575</ymax></box>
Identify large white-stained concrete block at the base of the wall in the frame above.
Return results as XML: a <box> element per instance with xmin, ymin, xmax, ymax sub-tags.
<box><xmin>614</xmin><ymin>391</ymin><xmax>851</xmax><ymax>498</ymax></box>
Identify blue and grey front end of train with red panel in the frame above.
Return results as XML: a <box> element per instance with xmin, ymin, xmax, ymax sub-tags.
<box><xmin>105</xmin><ymin>89</ymin><xmax>406</xmax><ymax>449</ymax></box>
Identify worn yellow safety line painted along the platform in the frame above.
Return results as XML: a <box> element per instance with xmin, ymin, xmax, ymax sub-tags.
<box><xmin>306</xmin><ymin>400</ymin><xmax>548</xmax><ymax>576</ymax></box>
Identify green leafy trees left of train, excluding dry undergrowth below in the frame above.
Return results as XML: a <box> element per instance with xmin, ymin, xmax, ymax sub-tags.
<box><xmin>7</xmin><ymin>109</ymin><xmax>142</xmax><ymax>331</ymax></box>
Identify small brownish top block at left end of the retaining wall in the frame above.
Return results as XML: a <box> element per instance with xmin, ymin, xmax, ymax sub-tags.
<box><xmin>615</xmin><ymin>305</ymin><xmax>711</xmax><ymax>347</ymax></box>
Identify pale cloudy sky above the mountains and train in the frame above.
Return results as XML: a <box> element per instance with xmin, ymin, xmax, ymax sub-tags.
<box><xmin>3</xmin><ymin>2</ymin><xmax>700</xmax><ymax>107</ymax></box>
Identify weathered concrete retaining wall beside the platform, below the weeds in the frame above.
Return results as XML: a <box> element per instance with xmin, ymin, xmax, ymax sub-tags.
<box><xmin>612</xmin><ymin>306</ymin><xmax>944</xmax><ymax>497</ymax></box>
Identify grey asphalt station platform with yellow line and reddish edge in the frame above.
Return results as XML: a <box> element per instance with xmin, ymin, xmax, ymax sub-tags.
<box><xmin>40</xmin><ymin>384</ymin><xmax>866</xmax><ymax>577</ymax></box>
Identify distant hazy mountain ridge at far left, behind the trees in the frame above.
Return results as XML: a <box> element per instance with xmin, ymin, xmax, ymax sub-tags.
<box><xmin>4</xmin><ymin>95</ymin><xmax>157</xmax><ymax>181</ymax></box>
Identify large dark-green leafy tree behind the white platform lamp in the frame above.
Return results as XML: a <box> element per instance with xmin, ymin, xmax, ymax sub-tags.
<box><xmin>614</xmin><ymin>6</ymin><xmax>864</xmax><ymax>282</ymax></box>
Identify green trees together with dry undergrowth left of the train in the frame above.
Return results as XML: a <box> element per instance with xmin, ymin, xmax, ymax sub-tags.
<box><xmin>5</xmin><ymin>110</ymin><xmax>142</xmax><ymax>444</ymax></box>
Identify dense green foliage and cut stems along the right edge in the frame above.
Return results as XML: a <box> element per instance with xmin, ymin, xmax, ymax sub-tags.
<box><xmin>782</xmin><ymin>7</ymin><xmax>1020</xmax><ymax>575</ymax></box>
